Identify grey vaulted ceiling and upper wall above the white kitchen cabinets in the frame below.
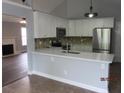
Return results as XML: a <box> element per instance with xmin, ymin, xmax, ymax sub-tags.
<box><xmin>4</xmin><ymin>0</ymin><xmax>121</xmax><ymax>19</ymax></box>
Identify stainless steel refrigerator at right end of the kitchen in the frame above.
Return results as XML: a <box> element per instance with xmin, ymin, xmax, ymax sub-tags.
<box><xmin>93</xmin><ymin>28</ymin><xmax>112</xmax><ymax>53</ymax></box>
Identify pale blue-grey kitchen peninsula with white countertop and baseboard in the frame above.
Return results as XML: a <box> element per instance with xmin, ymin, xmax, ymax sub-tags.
<box><xmin>32</xmin><ymin>48</ymin><xmax>113</xmax><ymax>93</ymax></box>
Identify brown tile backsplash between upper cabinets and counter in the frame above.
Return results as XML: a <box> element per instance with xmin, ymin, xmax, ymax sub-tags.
<box><xmin>35</xmin><ymin>37</ymin><xmax>92</xmax><ymax>52</ymax></box>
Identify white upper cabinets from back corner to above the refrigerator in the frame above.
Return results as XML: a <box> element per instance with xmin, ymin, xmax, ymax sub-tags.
<box><xmin>68</xmin><ymin>18</ymin><xmax>114</xmax><ymax>36</ymax></box>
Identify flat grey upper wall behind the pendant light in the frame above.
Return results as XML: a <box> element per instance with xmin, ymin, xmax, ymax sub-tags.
<box><xmin>67</xmin><ymin>0</ymin><xmax>121</xmax><ymax>18</ymax></box>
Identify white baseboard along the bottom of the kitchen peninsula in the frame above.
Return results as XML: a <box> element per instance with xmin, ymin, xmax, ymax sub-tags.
<box><xmin>32</xmin><ymin>71</ymin><xmax>108</xmax><ymax>93</ymax></box>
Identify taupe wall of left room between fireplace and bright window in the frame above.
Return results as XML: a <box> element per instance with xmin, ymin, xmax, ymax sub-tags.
<box><xmin>2</xmin><ymin>22</ymin><xmax>27</xmax><ymax>53</ymax></box>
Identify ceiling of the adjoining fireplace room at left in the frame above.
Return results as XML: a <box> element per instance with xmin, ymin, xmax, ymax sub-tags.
<box><xmin>2</xmin><ymin>15</ymin><xmax>22</xmax><ymax>23</ymax></box>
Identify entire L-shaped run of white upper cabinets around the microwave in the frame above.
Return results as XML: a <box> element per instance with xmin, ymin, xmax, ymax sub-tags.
<box><xmin>34</xmin><ymin>12</ymin><xmax>114</xmax><ymax>38</ymax></box>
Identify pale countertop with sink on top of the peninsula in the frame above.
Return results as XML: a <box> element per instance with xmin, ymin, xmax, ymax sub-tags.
<box><xmin>33</xmin><ymin>48</ymin><xmax>114</xmax><ymax>63</ymax></box>
